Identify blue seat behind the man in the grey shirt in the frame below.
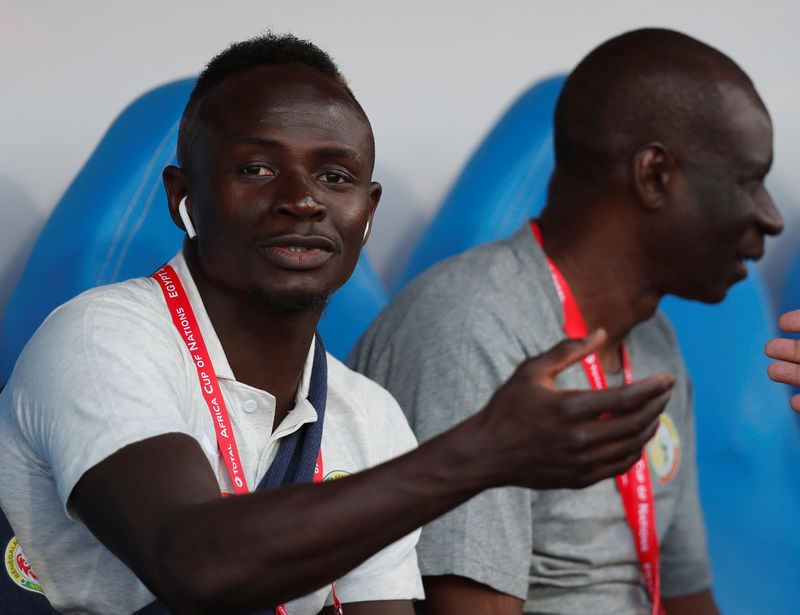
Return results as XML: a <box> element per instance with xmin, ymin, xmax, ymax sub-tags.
<box><xmin>400</xmin><ymin>77</ymin><xmax>800</xmax><ymax>615</ymax></box>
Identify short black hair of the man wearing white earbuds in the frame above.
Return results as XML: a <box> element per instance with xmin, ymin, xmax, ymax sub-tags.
<box><xmin>177</xmin><ymin>32</ymin><xmax>363</xmax><ymax>166</ymax></box>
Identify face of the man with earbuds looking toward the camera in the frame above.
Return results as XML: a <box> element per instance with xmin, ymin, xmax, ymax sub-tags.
<box><xmin>184</xmin><ymin>64</ymin><xmax>380</xmax><ymax>310</ymax></box>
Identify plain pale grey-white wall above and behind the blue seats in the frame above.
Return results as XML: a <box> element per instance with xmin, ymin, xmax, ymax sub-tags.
<box><xmin>0</xmin><ymin>0</ymin><xmax>800</xmax><ymax>318</ymax></box>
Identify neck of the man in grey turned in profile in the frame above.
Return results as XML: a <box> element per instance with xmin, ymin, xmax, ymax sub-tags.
<box><xmin>539</xmin><ymin>206</ymin><xmax>661</xmax><ymax>373</ymax></box>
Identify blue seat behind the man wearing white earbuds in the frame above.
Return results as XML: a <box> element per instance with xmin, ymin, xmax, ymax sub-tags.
<box><xmin>0</xmin><ymin>79</ymin><xmax>387</xmax><ymax>383</ymax></box>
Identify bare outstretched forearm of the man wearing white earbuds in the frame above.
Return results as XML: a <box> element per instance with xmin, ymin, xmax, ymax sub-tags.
<box><xmin>156</xmin><ymin>418</ymin><xmax>489</xmax><ymax>612</ymax></box>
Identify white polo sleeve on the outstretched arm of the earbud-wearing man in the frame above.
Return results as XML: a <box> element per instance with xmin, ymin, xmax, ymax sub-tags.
<box><xmin>8</xmin><ymin>281</ymin><xmax>195</xmax><ymax>514</ymax></box>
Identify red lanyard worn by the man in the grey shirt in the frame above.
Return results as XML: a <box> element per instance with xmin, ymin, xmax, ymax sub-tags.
<box><xmin>531</xmin><ymin>221</ymin><xmax>664</xmax><ymax>615</ymax></box>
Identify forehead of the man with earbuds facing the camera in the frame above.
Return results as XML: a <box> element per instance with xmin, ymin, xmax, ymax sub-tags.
<box><xmin>200</xmin><ymin>64</ymin><xmax>373</xmax><ymax>162</ymax></box>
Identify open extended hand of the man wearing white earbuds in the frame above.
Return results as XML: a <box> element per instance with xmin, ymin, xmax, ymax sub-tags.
<box><xmin>475</xmin><ymin>330</ymin><xmax>674</xmax><ymax>489</ymax></box>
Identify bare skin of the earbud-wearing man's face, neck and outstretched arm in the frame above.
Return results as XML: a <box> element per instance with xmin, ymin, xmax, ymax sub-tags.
<box><xmin>69</xmin><ymin>65</ymin><xmax>673</xmax><ymax>615</ymax></box>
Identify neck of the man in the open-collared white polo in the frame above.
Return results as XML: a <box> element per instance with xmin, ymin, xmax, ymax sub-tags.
<box><xmin>184</xmin><ymin>250</ymin><xmax>322</xmax><ymax>430</ymax></box>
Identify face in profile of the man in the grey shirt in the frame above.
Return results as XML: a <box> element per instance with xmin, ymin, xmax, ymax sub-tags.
<box><xmin>671</xmin><ymin>84</ymin><xmax>782</xmax><ymax>303</ymax></box>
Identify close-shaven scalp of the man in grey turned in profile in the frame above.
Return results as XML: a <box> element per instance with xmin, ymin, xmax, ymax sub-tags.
<box><xmin>554</xmin><ymin>29</ymin><xmax>763</xmax><ymax>184</ymax></box>
